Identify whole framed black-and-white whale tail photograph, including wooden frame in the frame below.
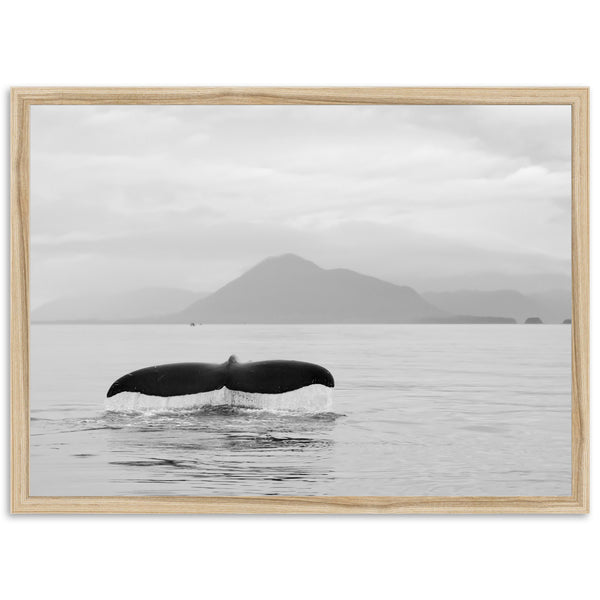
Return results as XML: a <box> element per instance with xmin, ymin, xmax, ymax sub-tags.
<box><xmin>11</xmin><ymin>88</ymin><xmax>589</xmax><ymax>513</ymax></box>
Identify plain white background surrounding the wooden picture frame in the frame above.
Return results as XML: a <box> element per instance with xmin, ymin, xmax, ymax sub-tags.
<box><xmin>0</xmin><ymin>0</ymin><xmax>600</xmax><ymax>600</ymax></box>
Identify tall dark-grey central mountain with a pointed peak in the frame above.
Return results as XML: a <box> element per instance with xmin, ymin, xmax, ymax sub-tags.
<box><xmin>171</xmin><ymin>254</ymin><xmax>445</xmax><ymax>323</ymax></box>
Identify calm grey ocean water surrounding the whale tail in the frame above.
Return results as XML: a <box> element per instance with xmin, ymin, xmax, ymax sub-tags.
<box><xmin>30</xmin><ymin>325</ymin><xmax>571</xmax><ymax>496</ymax></box>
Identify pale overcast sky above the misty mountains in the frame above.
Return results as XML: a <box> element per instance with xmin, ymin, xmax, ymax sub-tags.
<box><xmin>31</xmin><ymin>106</ymin><xmax>571</xmax><ymax>307</ymax></box>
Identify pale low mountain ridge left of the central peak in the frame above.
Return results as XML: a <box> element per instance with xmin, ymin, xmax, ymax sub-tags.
<box><xmin>31</xmin><ymin>288</ymin><xmax>202</xmax><ymax>323</ymax></box>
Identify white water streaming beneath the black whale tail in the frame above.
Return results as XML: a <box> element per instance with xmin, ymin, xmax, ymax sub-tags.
<box><xmin>105</xmin><ymin>384</ymin><xmax>333</xmax><ymax>412</ymax></box>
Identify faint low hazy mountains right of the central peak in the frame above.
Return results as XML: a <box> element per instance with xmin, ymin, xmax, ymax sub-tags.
<box><xmin>423</xmin><ymin>290</ymin><xmax>571</xmax><ymax>323</ymax></box>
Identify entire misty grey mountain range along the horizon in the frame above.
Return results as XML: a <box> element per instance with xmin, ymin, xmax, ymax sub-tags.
<box><xmin>31</xmin><ymin>254</ymin><xmax>571</xmax><ymax>323</ymax></box>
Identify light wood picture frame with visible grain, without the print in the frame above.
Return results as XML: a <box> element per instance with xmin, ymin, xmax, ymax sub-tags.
<box><xmin>10</xmin><ymin>87</ymin><xmax>589</xmax><ymax>513</ymax></box>
